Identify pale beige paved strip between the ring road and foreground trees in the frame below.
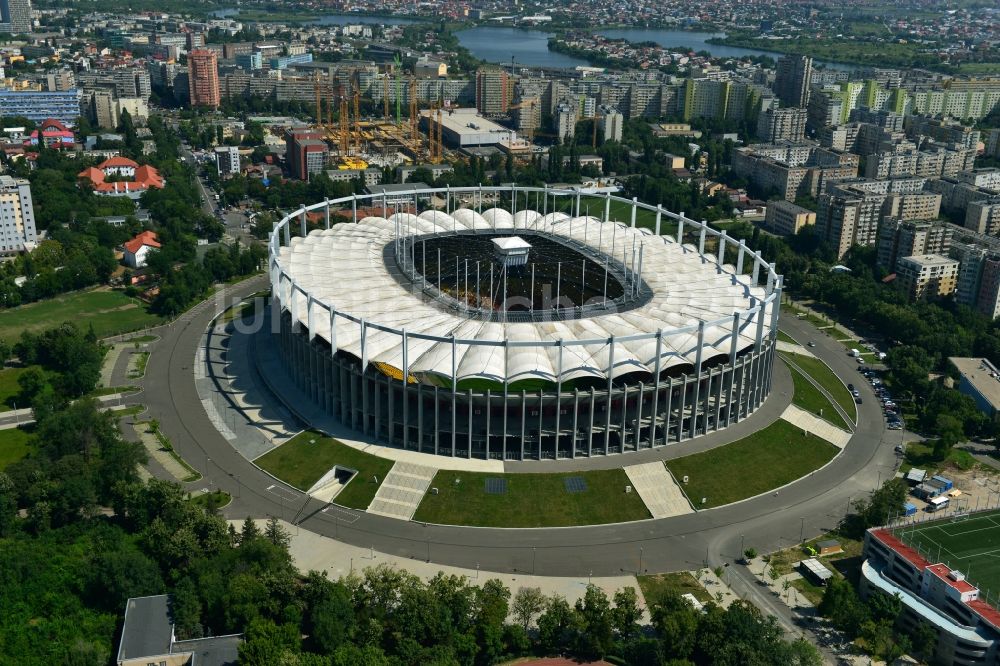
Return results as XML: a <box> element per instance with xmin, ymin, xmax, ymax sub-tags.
<box><xmin>241</xmin><ymin>519</ymin><xmax>648</xmax><ymax>623</ymax></box>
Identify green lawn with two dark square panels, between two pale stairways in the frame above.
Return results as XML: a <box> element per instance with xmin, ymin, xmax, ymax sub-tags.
<box><xmin>413</xmin><ymin>469</ymin><xmax>649</xmax><ymax>527</ymax></box>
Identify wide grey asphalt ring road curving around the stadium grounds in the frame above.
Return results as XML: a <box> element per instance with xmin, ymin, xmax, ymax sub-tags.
<box><xmin>141</xmin><ymin>256</ymin><xmax>897</xmax><ymax>584</ymax></box>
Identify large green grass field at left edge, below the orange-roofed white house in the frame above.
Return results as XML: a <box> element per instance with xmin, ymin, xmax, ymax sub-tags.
<box><xmin>0</xmin><ymin>289</ymin><xmax>162</xmax><ymax>343</ymax></box>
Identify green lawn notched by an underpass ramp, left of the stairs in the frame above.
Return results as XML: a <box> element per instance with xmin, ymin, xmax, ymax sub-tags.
<box><xmin>254</xmin><ymin>431</ymin><xmax>393</xmax><ymax>509</ymax></box>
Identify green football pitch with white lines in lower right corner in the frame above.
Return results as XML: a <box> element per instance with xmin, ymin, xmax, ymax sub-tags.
<box><xmin>893</xmin><ymin>511</ymin><xmax>1000</xmax><ymax>600</ymax></box>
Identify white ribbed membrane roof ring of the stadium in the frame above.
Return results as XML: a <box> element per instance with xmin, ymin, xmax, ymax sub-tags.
<box><xmin>275</xmin><ymin>208</ymin><xmax>770</xmax><ymax>381</ymax></box>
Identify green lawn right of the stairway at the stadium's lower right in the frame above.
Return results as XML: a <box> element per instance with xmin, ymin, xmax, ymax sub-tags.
<box><xmin>667</xmin><ymin>419</ymin><xmax>837</xmax><ymax>508</ymax></box>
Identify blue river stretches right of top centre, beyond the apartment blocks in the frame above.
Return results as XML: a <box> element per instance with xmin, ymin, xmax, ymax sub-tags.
<box><xmin>455</xmin><ymin>26</ymin><xmax>857</xmax><ymax>71</ymax></box>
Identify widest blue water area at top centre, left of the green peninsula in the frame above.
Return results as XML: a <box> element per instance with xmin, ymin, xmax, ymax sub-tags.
<box><xmin>455</xmin><ymin>26</ymin><xmax>590</xmax><ymax>68</ymax></box>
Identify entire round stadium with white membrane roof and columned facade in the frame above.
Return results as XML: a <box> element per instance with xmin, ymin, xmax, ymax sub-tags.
<box><xmin>269</xmin><ymin>186</ymin><xmax>782</xmax><ymax>460</ymax></box>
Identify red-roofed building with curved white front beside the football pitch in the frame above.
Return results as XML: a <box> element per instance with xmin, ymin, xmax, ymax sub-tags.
<box><xmin>861</xmin><ymin>528</ymin><xmax>1000</xmax><ymax>665</ymax></box>
